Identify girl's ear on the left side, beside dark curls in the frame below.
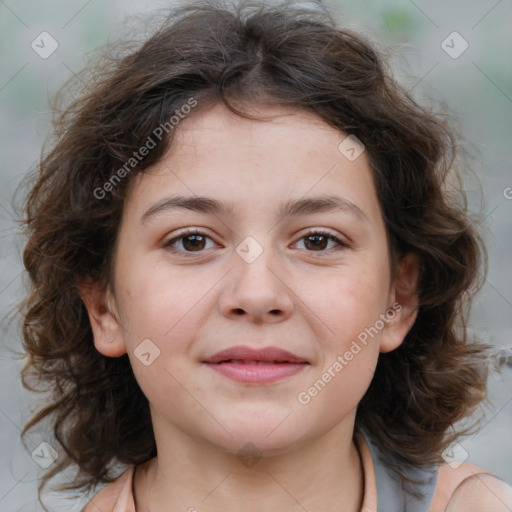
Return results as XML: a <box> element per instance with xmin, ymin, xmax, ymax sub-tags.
<box><xmin>79</xmin><ymin>282</ymin><xmax>126</xmax><ymax>357</ymax></box>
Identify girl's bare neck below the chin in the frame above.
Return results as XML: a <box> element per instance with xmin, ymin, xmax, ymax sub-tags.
<box><xmin>134</xmin><ymin>414</ymin><xmax>363</xmax><ymax>512</ymax></box>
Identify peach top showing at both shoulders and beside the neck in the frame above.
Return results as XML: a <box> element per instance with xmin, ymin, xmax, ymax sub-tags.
<box><xmin>82</xmin><ymin>434</ymin><xmax>487</xmax><ymax>512</ymax></box>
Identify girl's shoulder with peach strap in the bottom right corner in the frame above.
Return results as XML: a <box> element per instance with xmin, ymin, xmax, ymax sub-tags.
<box><xmin>429</xmin><ymin>464</ymin><xmax>512</xmax><ymax>512</ymax></box>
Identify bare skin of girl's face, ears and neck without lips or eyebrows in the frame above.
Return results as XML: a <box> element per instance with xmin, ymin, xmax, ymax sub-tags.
<box><xmin>82</xmin><ymin>105</ymin><xmax>418</xmax><ymax>512</ymax></box>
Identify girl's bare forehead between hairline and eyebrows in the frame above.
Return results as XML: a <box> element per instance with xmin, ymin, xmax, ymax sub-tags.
<box><xmin>126</xmin><ymin>104</ymin><xmax>380</xmax><ymax>225</ymax></box>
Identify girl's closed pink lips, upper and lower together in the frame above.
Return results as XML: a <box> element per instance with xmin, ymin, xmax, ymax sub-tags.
<box><xmin>202</xmin><ymin>345</ymin><xmax>310</xmax><ymax>384</ymax></box>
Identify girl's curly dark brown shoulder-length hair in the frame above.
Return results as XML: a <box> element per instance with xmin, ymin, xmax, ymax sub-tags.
<box><xmin>21</xmin><ymin>2</ymin><xmax>486</xmax><ymax>506</ymax></box>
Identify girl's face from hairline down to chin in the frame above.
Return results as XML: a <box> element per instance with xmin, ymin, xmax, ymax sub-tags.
<box><xmin>88</xmin><ymin>101</ymin><xmax>414</xmax><ymax>453</ymax></box>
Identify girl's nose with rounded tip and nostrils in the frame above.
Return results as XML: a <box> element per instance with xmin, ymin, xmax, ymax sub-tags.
<box><xmin>218</xmin><ymin>239</ymin><xmax>295</xmax><ymax>324</ymax></box>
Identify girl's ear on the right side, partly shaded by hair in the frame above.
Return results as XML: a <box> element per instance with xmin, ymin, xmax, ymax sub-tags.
<box><xmin>380</xmin><ymin>253</ymin><xmax>420</xmax><ymax>352</ymax></box>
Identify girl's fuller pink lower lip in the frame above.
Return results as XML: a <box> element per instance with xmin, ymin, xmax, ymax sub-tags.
<box><xmin>207</xmin><ymin>363</ymin><xmax>309</xmax><ymax>384</ymax></box>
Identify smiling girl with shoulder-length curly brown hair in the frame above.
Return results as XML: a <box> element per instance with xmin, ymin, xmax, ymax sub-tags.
<box><xmin>22</xmin><ymin>2</ymin><xmax>512</xmax><ymax>512</ymax></box>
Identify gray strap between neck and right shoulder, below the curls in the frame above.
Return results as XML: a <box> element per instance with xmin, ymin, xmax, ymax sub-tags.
<box><xmin>363</xmin><ymin>433</ymin><xmax>438</xmax><ymax>512</ymax></box>
